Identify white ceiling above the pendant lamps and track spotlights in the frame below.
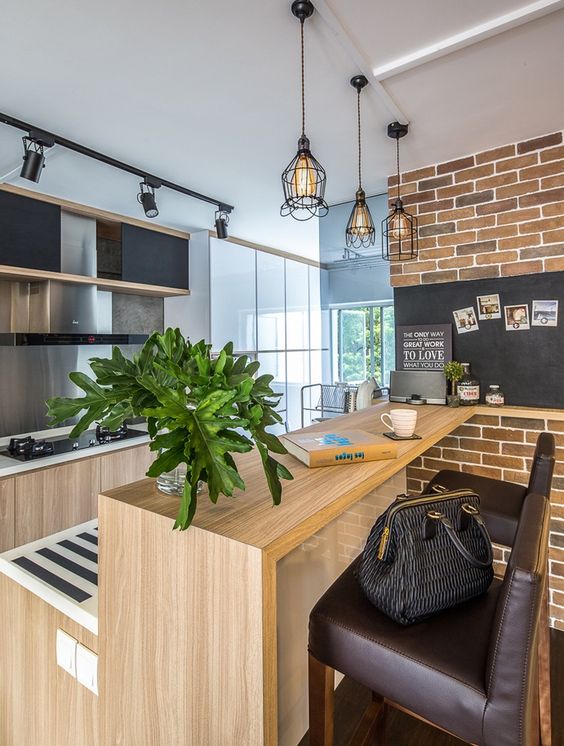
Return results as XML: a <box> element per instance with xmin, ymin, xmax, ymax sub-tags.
<box><xmin>0</xmin><ymin>0</ymin><xmax>564</xmax><ymax>257</ymax></box>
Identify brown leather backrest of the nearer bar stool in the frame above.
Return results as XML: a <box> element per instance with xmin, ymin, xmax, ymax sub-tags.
<box><xmin>483</xmin><ymin>494</ymin><xmax>550</xmax><ymax>746</ymax></box>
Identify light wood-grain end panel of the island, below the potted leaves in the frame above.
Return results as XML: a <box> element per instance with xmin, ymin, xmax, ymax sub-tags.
<box><xmin>99</xmin><ymin>495</ymin><xmax>264</xmax><ymax>746</ymax></box>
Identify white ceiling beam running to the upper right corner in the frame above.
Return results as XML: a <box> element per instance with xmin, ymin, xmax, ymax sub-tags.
<box><xmin>372</xmin><ymin>0</ymin><xmax>564</xmax><ymax>83</ymax></box>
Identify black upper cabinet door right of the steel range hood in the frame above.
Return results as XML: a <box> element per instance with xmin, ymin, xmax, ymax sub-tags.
<box><xmin>121</xmin><ymin>223</ymin><xmax>188</xmax><ymax>290</ymax></box>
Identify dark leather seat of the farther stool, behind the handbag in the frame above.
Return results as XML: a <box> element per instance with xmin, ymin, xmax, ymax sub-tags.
<box><xmin>424</xmin><ymin>469</ymin><xmax>527</xmax><ymax>547</ymax></box>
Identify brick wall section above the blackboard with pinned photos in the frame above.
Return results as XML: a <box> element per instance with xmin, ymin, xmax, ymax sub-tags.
<box><xmin>388</xmin><ymin>132</ymin><xmax>564</xmax><ymax>287</ymax></box>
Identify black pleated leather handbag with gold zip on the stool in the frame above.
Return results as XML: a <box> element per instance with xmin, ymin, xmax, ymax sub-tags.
<box><xmin>358</xmin><ymin>486</ymin><xmax>493</xmax><ymax>625</ymax></box>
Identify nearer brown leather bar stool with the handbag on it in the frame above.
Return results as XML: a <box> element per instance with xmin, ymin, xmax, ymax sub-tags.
<box><xmin>309</xmin><ymin>494</ymin><xmax>550</xmax><ymax>746</ymax></box>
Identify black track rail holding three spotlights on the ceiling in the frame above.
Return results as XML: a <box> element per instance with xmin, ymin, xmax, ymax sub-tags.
<box><xmin>0</xmin><ymin>112</ymin><xmax>235</xmax><ymax>213</ymax></box>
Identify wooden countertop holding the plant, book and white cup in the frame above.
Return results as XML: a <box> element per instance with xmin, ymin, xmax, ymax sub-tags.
<box><xmin>101</xmin><ymin>402</ymin><xmax>564</xmax><ymax>559</ymax></box>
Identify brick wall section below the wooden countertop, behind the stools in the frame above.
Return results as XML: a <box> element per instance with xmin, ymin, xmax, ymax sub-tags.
<box><xmin>407</xmin><ymin>413</ymin><xmax>564</xmax><ymax>630</ymax></box>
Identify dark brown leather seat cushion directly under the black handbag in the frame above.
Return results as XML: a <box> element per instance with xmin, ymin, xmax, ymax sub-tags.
<box><xmin>309</xmin><ymin>559</ymin><xmax>500</xmax><ymax>743</ymax></box>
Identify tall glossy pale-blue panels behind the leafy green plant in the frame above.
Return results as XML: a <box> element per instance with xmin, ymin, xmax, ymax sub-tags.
<box><xmin>210</xmin><ymin>239</ymin><xmax>329</xmax><ymax>430</ymax></box>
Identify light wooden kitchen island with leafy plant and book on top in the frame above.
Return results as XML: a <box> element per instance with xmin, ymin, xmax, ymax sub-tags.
<box><xmin>99</xmin><ymin>404</ymin><xmax>476</xmax><ymax>746</ymax></box>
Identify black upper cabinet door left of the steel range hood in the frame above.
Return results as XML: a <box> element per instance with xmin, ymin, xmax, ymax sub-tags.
<box><xmin>0</xmin><ymin>191</ymin><xmax>61</xmax><ymax>272</ymax></box>
